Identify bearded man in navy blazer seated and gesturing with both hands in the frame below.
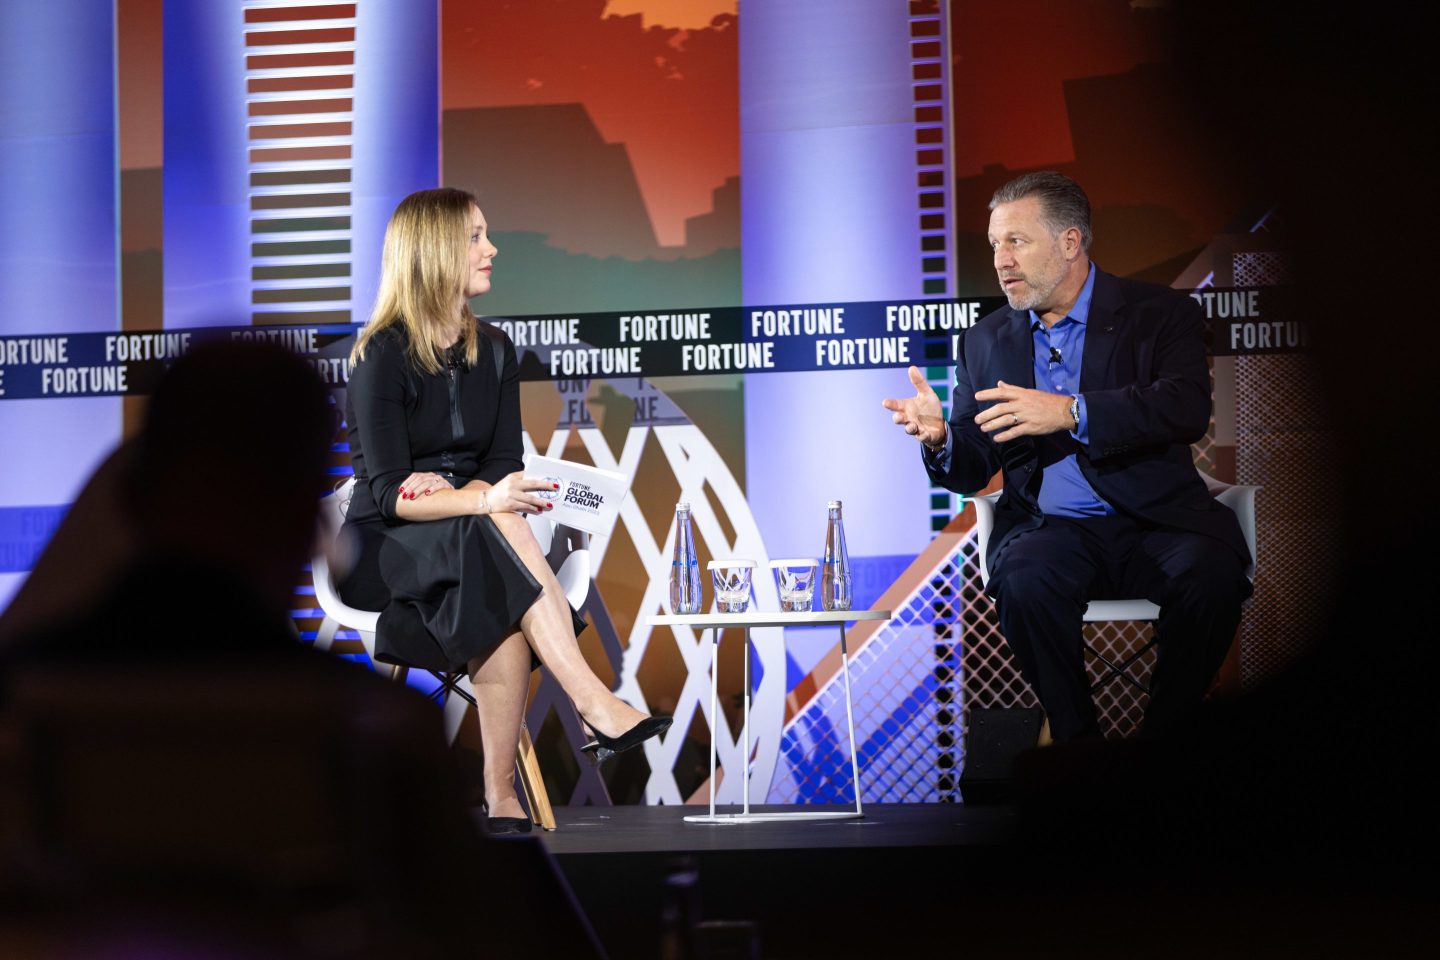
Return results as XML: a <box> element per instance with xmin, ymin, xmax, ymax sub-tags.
<box><xmin>884</xmin><ymin>173</ymin><xmax>1250</xmax><ymax>741</ymax></box>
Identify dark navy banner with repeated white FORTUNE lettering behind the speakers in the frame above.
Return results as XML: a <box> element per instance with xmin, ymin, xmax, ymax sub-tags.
<box><xmin>0</xmin><ymin>288</ymin><xmax>1309</xmax><ymax>400</ymax></box>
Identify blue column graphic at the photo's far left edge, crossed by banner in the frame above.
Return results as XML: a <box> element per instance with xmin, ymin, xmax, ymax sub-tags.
<box><xmin>0</xmin><ymin>0</ymin><xmax>121</xmax><ymax>607</ymax></box>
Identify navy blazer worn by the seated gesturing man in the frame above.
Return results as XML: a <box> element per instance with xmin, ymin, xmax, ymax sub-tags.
<box><xmin>924</xmin><ymin>268</ymin><xmax>1250</xmax><ymax>570</ymax></box>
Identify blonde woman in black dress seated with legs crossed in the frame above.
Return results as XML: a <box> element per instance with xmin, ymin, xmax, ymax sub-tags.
<box><xmin>340</xmin><ymin>189</ymin><xmax>670</xmax><ymax>833</ymax></box>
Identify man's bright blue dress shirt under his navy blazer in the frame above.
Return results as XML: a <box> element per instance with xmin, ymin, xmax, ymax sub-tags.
<box><xmin>926</xmin><ymin>263</ymin><xmax>1115</xmax><ymax>517</ymax></box>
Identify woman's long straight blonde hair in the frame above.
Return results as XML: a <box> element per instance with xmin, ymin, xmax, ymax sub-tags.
<box><xmin>350</xmin><ymin>187</ymin><xmax>480</xmax><ymax>373</ymax></box>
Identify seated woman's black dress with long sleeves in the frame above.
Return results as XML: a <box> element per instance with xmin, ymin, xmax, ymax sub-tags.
<box><xmin>338</xmin><ymin>324</ymin><xmax>555</xmax><ymax>671</ymax></box>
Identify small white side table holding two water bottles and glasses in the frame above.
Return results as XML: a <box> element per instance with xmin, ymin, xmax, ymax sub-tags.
<box><xmin>645</xmin><ymin>610</ymin><xmax>890</xmax><ymax>823</ymax></box>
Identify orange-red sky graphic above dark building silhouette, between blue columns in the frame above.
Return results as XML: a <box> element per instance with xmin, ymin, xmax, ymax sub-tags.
<box><xmin>441</xmin><ymin>0</ymin><xmax>740</xmax><ymax>246</ymax></box>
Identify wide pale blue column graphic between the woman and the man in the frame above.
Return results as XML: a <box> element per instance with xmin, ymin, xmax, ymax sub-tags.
<box><xmin>740</xmin><ymin>0</ymin><xmax>930</xmax><ymax>566</ymax></box>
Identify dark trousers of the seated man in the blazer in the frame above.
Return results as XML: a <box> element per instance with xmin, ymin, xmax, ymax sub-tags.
<box><xmin>986</xmin><ymin>515</ymin><xmax>1250</xmax><ymax>741</ymax></box>
